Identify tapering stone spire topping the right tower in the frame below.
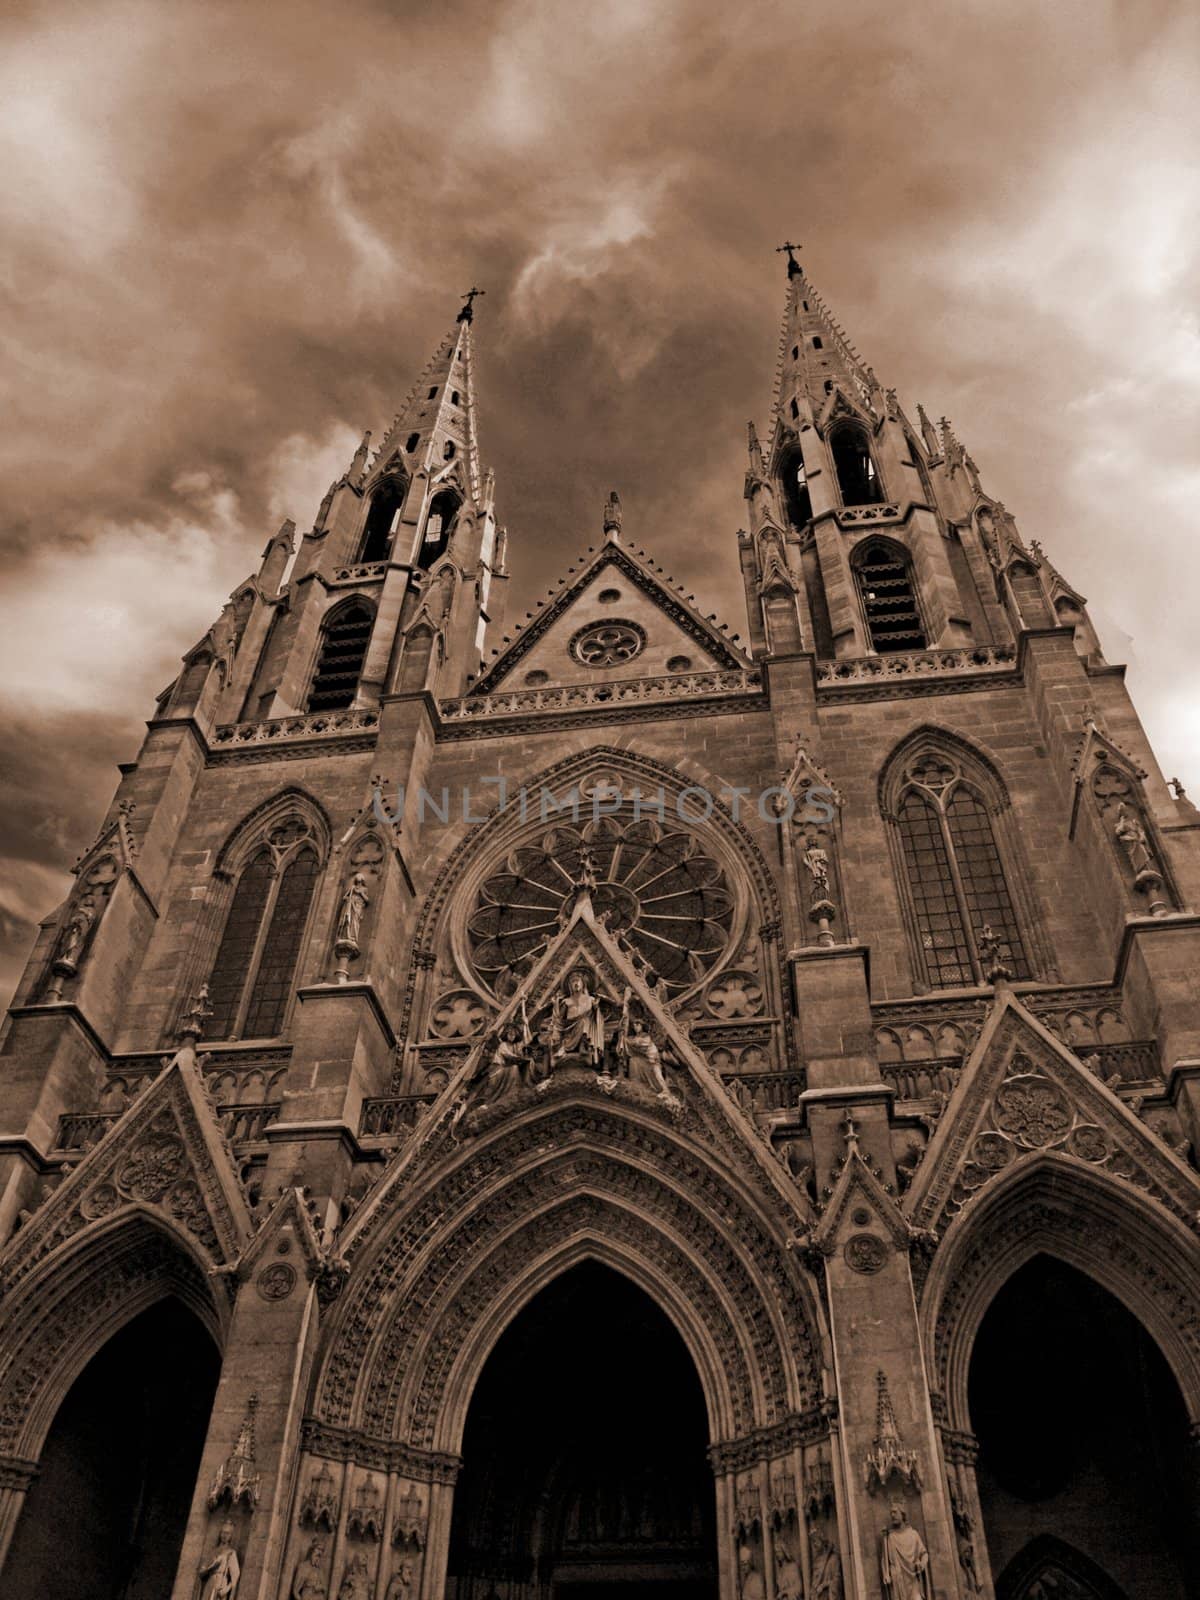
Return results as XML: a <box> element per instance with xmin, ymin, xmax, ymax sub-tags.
<box><xmin>774</xmin><ymin>243</ymin><xmax>883</xmax><ymax>427</ymax></box>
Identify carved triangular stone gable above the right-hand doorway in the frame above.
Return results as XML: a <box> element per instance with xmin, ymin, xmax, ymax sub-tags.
<box><xmin>904</xmin><ymin>986</ymin><xmax>1200</xmax><ymax>1234</ymax></box>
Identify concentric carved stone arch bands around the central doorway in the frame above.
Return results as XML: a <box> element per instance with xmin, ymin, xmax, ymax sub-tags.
<box><xmin>317</xmin><ymin>1102</ymin><xmax>821</xmax><ymax>1450</ymax></box>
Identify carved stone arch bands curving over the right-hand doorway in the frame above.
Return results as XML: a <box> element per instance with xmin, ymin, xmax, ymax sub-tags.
<box><xmin>922</xmin><ymin>1154</ymin><xmax>1200</xmax><ymax>1429</ymax></box>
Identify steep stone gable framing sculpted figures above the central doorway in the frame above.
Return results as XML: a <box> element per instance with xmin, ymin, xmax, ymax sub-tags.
<box><xmin>339</xmin><ymin>893</ymin><xmax>811</xmax><ymax>1256</ymax></box>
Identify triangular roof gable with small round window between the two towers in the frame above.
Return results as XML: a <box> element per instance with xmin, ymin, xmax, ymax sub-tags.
<box><xmin>472</xmin><ymin>539</ymin><xmax>750</xmax><ymax>694</ymax></box>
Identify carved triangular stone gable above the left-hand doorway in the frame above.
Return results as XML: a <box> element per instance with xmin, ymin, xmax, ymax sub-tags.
<box><xmin>0</xmin><ymin>1048</ymin><xmax>253</xmax><ymax>1290</ymax></box>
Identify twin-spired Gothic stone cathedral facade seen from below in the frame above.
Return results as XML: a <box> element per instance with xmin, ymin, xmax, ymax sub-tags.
<box><xmin>0</xmin><ymin>246</ymin><xmax>1200</xmax><ymax>1600</ymax></box>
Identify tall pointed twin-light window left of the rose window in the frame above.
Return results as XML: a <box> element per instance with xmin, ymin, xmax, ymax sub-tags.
<box><xmin>205</xmin><ymin>818</ymin><xmax>320</xmax><ymax>1038</ymax></box>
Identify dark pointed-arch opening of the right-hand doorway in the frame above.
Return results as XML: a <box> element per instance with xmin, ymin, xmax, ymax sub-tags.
<box><xmin>968</xmin><ymin>1254</ymin><xmax>1200</xmax><ymax>1600</ymax></box>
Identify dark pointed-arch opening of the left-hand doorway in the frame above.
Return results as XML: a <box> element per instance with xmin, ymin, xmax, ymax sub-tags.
<box><xmin>0</xmin><ymin>1299</ymin><xmax>221</xmax><ymax>1600</ymax></box>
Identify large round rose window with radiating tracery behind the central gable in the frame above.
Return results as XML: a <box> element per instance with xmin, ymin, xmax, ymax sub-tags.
<box><xmin>467</xmin><ymin>816</ymin><xmax>733</xmax><ymax>995</ymax></box>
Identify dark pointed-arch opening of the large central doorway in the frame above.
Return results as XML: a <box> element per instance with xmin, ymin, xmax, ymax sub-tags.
<box><xmin>446</xmin><ymin>1262</ymin><xmax>717</xmax><ymax>1600</ymax></box>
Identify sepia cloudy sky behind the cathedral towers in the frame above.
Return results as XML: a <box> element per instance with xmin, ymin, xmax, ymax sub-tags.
<box><xmin>0</xmin><ymin>0</ymin><xmax>1200</xmax><ymax>997</ymax></box>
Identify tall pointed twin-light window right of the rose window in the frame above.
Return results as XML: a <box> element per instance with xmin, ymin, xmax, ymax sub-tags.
<box><xmin>891</xmin><ymin>747</ymin><xmax>1032</xmax><ymax>989</ymax></box>
